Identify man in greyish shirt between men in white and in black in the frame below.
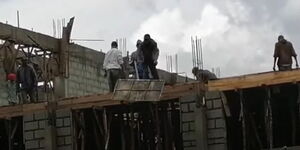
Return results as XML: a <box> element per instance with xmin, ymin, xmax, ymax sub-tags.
<box><xmin>131</xmin><ymin>40</ymin><xmax>144</xmax><ymax>79</ymax></box>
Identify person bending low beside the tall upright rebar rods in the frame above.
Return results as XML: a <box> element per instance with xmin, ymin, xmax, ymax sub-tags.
<box><xmin>192</xmin><ymin>67</ymin><xmax>217</xmax><ymax>83</ymax></box>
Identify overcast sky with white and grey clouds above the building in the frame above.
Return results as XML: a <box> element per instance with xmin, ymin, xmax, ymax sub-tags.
<box><xmin>0</xmin><ymin>0</ymin><xmax>300</xmax><ymax>77</ymax></box>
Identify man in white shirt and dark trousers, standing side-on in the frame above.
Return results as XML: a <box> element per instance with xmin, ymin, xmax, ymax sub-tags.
<box><xmin>103</xmin><ymin>41</ymin><xmax>124</xmax><ymax>92</ymax></box>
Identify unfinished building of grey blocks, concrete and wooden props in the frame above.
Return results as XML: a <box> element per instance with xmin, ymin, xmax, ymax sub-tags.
<box><xmin>0</xmin><ymin>19</ymin><xmax>300</xmax><ymax>150</ymax></box>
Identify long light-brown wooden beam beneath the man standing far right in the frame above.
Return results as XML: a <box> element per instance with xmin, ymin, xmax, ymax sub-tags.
<box><xmin>207</xmin><ymin>69</ymin><xmax>300</xmax><ymax>91</ymax></box>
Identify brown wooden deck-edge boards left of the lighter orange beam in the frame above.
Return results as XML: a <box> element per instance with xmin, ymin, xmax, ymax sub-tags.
<box><xmin>0</xmin><ymin>82</ymin><xmax>204</xmax><ymax>118</ymax></box>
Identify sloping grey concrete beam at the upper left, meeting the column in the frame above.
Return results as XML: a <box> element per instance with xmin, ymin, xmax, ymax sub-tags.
<box><xmin>0</xmin><ymin>22</ymin><xmax>60</xmax><ymax>52</ymax></box>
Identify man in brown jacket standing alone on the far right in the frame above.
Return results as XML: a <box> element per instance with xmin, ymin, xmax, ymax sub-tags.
<box><xmin>273</xmin><ymin>35</ymin><xmax>299</xmax><ymax>71</ymax></box>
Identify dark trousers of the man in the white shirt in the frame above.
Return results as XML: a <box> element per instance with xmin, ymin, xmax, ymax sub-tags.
<box><xmin>107</xmin><ymin>69</ymin><xmax>122</xmax><ymax>92</ymax></box>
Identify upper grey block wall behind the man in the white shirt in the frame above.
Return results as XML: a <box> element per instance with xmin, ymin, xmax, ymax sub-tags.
<box><xmin>65</xmin><ymin>44</ymin><xmax>108</xmax><ymax>97</ymax></box>
